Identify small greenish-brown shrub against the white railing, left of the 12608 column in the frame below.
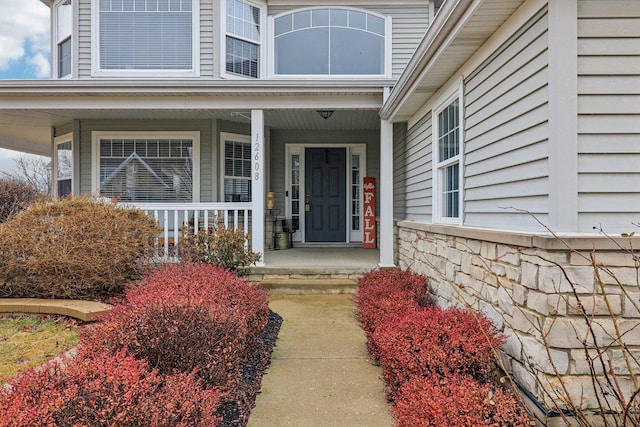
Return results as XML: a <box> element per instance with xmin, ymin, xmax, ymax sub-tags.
<box><xmin>180</xmin><ymin>226</ymin><xmax>261</xmax><ymax>271</ymax></box>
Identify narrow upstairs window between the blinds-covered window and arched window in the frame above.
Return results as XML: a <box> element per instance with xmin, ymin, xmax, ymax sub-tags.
<box><xmin>224</xmin><ymin>0</ymin><xmax>262</xmax><ymax>78</ymax></box>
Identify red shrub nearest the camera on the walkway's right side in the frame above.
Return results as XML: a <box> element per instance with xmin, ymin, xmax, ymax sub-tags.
<box><xmin>392</xmin><ymin>375</ymin><xmax>531</xmax><ymax>427</ymax></box>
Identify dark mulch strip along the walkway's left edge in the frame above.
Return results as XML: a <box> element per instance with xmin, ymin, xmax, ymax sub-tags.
<box><xmin>218</xmin><ymin>311</ymin><xmax>282</xmax><ymax>427</ymax></box>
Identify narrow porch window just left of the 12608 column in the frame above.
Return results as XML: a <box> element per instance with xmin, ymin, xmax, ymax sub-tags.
<box><xmin>222</xmin><ymin>134</ymin><xmax>251</xmax><ymax>202</ymax></box>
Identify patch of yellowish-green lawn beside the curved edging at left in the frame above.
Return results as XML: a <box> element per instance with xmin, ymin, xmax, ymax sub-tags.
<box><xmin>0</xmin><ymin>315</ymin><xmax>78</xmax><ymax>384</ymax></box>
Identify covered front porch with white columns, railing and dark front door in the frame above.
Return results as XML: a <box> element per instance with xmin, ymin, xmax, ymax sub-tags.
<box><xmin>0</xmin><ymin>80</ymin><xmax>393</xmax><ymax>270</ymax></box>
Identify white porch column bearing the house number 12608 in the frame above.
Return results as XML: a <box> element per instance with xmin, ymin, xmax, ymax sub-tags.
<box><xmin>251</xmin><ymin>110</ymin><xmax>265</xmax><ymax>265</ymax></box>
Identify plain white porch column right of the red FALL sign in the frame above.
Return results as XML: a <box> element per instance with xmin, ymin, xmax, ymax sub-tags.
<box><xmin>379</xmin><ymin>120</ymin><xmax>395</xmax><ymax>268</ymax></box>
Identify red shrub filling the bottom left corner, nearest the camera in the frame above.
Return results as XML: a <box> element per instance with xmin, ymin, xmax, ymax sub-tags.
<box><xmin>0</xmin><ymin>350</ymin><xmax>222</xmax><ymax>427</ymax></box>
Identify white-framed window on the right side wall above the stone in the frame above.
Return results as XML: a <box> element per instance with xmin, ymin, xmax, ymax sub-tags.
<box><xmin>434</xmin><ymin>98</ymin><xmax>462</xmax><ymax>222</ymax></box>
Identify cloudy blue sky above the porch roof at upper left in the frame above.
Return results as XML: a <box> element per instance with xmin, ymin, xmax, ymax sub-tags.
<box><xmin>0</xmin><ymin>0</ymin><xmax>49</xmax><ymax>75</ymax></box>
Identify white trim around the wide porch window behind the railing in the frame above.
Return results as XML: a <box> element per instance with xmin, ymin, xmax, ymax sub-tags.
<box><xmin>91</xmin><ymin>131</ymin><xmax>200</xmax><ymax>203</ymax></box>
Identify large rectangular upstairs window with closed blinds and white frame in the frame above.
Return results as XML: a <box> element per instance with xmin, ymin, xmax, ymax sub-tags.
<box><xmin>94</xmin><ymin>0</ymin><xmax>199</xmax><ymax>75</ymax></box>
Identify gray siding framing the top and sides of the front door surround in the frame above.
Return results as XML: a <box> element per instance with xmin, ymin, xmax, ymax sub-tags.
<box><xmin>267</xmin><ymin>129</ymin><xmax>380</xmax><ymax>213</ymax></box>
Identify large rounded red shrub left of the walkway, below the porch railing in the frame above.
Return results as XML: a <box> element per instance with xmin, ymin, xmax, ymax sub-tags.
<box><xmin>81</xmin><ymin>264</ymin><xmax>269</xmax><ymax>390</ymax></box>
